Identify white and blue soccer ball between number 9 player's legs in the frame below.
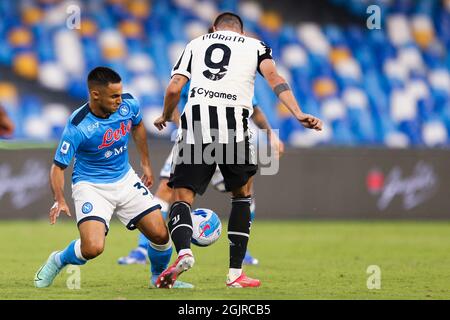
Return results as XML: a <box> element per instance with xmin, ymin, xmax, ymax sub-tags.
<box><xmin>191</xmin><ymin>208</ymin><xmax>222</xmax><ymax>247</ymax></box>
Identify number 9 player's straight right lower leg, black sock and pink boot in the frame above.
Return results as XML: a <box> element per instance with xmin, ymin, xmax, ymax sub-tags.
<box><xmin>226</xmin><ymin>196</ymin><xmax>261</xmax><ymax>288</ymax></box>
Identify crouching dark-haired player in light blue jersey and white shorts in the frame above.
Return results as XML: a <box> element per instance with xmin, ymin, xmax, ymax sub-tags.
<box><xmin>34</xmin><ymin>67</ymin><xmax>192</xmax><ymax>288</ymax></box>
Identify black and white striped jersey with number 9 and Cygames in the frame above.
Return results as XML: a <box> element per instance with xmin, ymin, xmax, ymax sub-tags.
<box><xmin>172</xmin><ymin>31</ymin><xmax>272</xmax><ymax>144</ymax></box>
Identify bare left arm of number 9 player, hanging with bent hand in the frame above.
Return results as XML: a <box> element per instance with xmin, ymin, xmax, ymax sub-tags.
<box><xmin>153</xmin><ymin>74</ymin><xmax>189</xmax><ymax>130</ymax></box>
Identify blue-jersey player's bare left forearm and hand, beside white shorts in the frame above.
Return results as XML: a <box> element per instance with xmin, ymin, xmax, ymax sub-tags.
<box><xmin>49</xmin><ymin>164</ymin><xmax>70</xmax><ymax>224</ymax></box>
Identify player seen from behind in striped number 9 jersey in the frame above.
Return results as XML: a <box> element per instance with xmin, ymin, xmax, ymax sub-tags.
<box><xmin>154</xmin><ymin>12</ymin><xmax>322</xmax><ymax>288</ymax></box>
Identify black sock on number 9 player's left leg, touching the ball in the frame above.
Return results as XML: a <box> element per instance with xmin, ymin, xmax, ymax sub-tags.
<box><xmin>168</xmin><ymin>201</ymin><xmax>192</xmax><ymax>252</ymax></box>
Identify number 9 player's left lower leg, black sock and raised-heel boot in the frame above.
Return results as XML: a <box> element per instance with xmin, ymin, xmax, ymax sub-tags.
<box><xmin>156</xmin><ymin>201</ymin><xmax>195</xmax><ymax>289</ymax></box>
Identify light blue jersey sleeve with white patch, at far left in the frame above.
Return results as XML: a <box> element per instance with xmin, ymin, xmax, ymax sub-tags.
<box><xmin>53</xmin><ymin>120</ymin><xmax>83</xmax><ymax>169</ymax></box>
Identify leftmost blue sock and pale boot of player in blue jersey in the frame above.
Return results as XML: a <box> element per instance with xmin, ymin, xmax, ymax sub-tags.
<box><xmin>34</xmin><ymin>239</ymin><xmax>86</xmax><ymax>288</ymax></box>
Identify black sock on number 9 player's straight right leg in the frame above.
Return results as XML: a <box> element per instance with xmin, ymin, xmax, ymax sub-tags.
<box><xmin>228</xmin><ymin>197</ymin><xmax>252</xmax><ymax>269</ymax></box>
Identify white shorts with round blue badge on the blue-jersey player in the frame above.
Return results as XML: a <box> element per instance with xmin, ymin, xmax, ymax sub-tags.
<box><xmin>72</xmin><ymin>169</ymin><xmax>161</xmax><ymax>232</ymax></box>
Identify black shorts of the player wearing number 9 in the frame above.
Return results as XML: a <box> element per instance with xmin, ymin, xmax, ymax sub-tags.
<box><xmin>167</xmin><ymin>139</ymin><xmax>258</xmax><ymax>195</ymax></box>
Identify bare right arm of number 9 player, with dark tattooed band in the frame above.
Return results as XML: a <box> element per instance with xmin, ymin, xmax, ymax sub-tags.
<box><xmin>259</xmin><ymin>59</ymin><xmax>322</xmax><ymax>131</ymax></box>
